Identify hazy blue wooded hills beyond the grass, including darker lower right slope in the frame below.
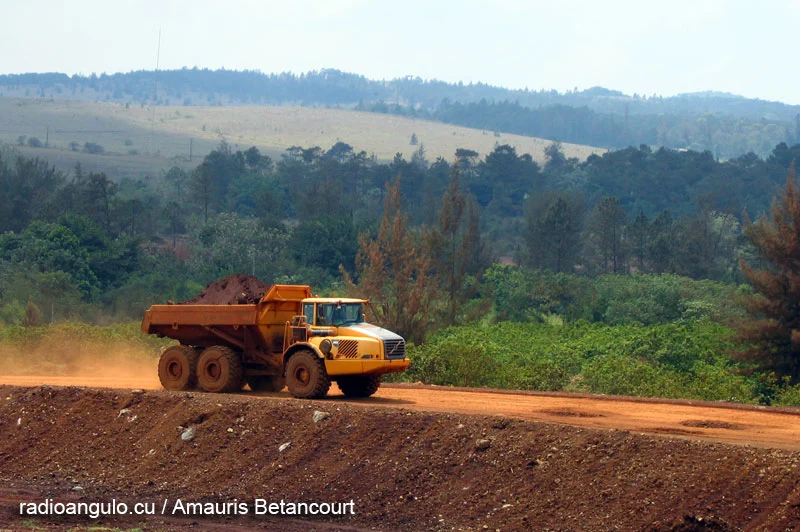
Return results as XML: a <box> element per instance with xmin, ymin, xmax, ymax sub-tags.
<box><xmin>0</xmin><ymin>68</ymin><xmax>800</xmax><ymax>159</ymax></box>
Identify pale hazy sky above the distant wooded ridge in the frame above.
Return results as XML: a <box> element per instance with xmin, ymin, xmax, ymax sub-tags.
<box><xmin>0</xmin><ymin>0</ymin><xmax>800</xmax><ymax>104</ymax></box>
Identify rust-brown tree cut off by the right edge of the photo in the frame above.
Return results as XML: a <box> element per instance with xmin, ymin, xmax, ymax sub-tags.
<box><xmin>738</xmin><ymin>164</ymin><xmax>800</xmax><ymax>384</ymax></box>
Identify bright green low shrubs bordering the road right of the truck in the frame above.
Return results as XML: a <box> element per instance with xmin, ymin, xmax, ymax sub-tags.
<box><xmin>398</xmin><ymin>321</ymin><xmax>762</xmax><ymax>402</ymax></box>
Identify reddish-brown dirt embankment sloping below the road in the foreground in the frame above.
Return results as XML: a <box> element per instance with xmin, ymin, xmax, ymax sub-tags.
<box><xmin>0</xmin><ymin>386</ymin><xmax>800</xmax><ymax>530</ymax></box>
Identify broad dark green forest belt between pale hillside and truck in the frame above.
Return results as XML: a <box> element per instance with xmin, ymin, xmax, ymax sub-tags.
<box><xmin>0</xmin><ymin>136</ymin><xmax>800</xmax><ymax>328</ymax></box>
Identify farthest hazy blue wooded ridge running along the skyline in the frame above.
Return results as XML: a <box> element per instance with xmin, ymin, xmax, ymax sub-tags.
<box><xmin>0</xmin><ymin>67</ymin><xmax>800</xmax><ymax>123</ymax></box>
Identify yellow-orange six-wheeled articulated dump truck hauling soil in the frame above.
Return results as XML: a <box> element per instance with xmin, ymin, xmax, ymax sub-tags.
<box><xmin>142</xmin><ymin>285</ymin><xmax>409</xmax><ymax>399</ymax></box>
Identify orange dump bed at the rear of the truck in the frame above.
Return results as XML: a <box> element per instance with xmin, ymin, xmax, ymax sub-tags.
<box><xmin>142</xmin><ymin>285</ymin><xmax>311</xmax><ymax>348</ymax></box>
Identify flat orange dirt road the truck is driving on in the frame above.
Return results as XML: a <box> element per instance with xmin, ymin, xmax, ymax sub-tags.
<box><xmin>6</xmin><ymin>371</ymin><xmax>800</xmax><ymax>450</ymax></box>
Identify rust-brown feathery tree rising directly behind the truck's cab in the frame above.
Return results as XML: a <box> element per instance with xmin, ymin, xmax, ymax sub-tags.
<box><xmin>341</xmin><ymin>180</ymin><xmax>437</xmax><ymax>343</ymax></box>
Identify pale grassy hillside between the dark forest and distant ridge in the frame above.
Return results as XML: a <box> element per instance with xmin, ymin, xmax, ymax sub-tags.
<box><xmin>0</xmin><ymin>97</ymin><xmax>604</xmax><ymax>181</ymax></box>
